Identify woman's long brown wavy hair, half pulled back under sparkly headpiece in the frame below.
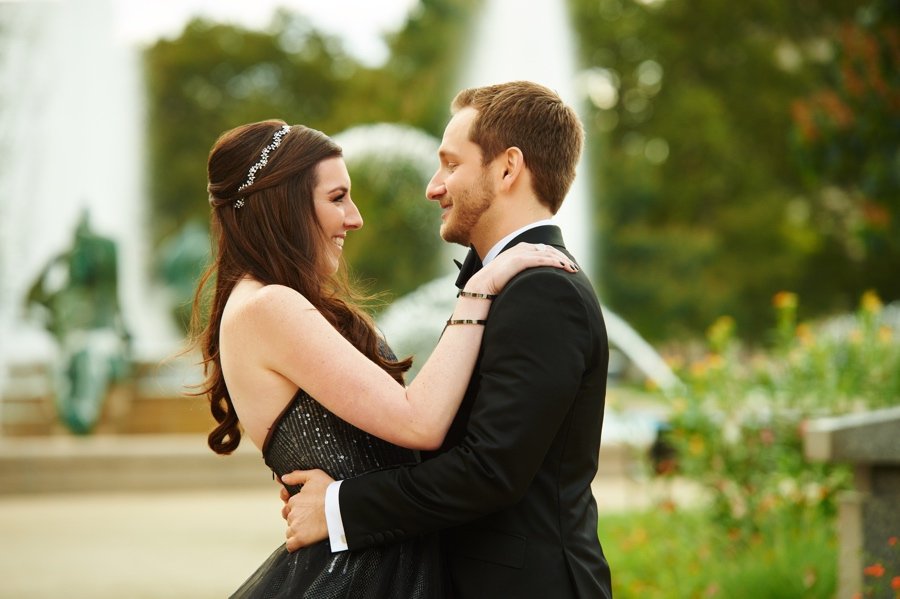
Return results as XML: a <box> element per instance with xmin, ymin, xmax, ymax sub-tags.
<box><xmin>191</xmin><ymin>120</ymin><xmax>412</xmax><ymax>454</ymax></box>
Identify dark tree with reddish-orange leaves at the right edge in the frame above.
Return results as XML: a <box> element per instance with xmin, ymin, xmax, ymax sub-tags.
<box><xmin>792</xmin><ymin>1</ymin><xmax>900</xmax><ymax>314</ymax></box>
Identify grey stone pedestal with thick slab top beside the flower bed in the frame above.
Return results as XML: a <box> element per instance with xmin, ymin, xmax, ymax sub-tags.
<box><xmin>804</xmin><ymin>406</ymin><xmax>900</xmax><ymax>599</ymax></box>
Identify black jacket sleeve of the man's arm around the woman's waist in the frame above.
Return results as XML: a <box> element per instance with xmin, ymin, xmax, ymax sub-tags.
<box><xmin>340</xmin><ymin>268</ymin><xmax>595</xmax><ymax>549</ymax></box>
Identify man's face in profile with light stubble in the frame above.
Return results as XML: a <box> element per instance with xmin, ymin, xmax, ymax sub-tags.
<box><xmin>425</xmin><ymin>108</ymin><xmax>494</xmax><ymax>246</ymax></box>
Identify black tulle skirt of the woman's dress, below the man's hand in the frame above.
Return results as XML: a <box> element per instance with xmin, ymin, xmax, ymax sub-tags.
<box><xmin>231</xmin><ymin>537</ymin><xmax>446</xmax><ymax>599</ymax></box>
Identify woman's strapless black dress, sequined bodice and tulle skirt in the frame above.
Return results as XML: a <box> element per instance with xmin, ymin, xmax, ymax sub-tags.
<box><xmin>232</xmin><ymin>390</ymin><xmax>444</xmax><ymax>599</ymax></box>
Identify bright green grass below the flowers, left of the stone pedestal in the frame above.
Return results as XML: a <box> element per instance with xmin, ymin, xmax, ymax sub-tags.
<box><xmin>599</xmin><ymin>507</ymin><xmax>837</xmax><ymax>599</ymax></box>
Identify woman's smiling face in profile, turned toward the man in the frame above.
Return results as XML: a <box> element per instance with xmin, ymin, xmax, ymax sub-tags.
<box><xmin>313</xmin><ymin>156</ymin><xmax>363</xmax><ymax>276</ymax></box>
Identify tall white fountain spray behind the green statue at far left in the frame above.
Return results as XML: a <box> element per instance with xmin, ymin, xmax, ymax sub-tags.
<box><xmin>0</xmin><ymin>0</ymin><xmax>178</xmax><ymax>432</ymax></box>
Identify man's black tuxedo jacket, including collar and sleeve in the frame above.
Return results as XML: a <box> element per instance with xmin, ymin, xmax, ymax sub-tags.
<box><xmin>339</xmin><ymin>226</ymin><xmax>612</xmax><ymax>599</ymax></box>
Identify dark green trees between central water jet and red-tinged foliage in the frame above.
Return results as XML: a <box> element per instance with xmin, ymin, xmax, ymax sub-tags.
<box><xmin>571</xmin><ymin>0</ymin><xmax>884</xmax><ymax>339</ymax></box>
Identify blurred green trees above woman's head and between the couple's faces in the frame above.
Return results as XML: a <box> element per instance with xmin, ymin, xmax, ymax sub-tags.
<box><xmin>144</xmin><ymin>0</ymin><xmax>474</xmax><ymax>321</ymax></box>
